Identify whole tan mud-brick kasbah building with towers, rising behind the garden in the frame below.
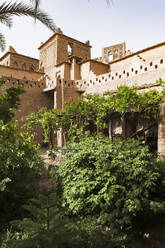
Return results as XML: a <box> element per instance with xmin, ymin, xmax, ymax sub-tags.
<box><xmin>0</xmin><ymin>29</ymin><xmax>165</xmax><ymax>160</ymax></box>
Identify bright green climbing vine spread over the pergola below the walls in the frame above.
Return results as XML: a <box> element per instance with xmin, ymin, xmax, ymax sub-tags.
<box><xmin>27</xmin><ymin>81</ymin><xmax>165</xmax><ymax>147</ymax></box>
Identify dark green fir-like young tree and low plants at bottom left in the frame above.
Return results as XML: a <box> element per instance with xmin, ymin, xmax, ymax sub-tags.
<box><xmin>2</xmin><ymin>192</ymin><xmax>120</xmax><ymax>248</ymax></box>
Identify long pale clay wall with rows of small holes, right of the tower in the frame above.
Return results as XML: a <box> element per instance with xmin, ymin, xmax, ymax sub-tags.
<box><xmin>78</xmin><ymin>47</ymin><xmax>165</xmax><ymax>94</ymax></box>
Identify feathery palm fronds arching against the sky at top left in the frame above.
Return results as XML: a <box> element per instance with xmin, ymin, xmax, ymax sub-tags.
<box><xmin>0</xmin><ymin>0</ymin><xmax>56</xmax><ymax>51</ymax></box>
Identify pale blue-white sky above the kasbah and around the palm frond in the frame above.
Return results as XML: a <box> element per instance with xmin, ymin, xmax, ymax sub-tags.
<box><xmin>0</xmin><ymin>0</ymin><xmax>165</xmax><ymax>58</ymax></box>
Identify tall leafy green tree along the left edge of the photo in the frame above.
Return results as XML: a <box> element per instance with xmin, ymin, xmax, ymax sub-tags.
<box><xmin>0</xmin><ymin>83</ymin><xmax>43</xmax><ymax>230</ymax></box>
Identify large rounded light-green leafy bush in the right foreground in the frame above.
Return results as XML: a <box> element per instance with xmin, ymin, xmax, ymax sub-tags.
<box><xmin>59</xmin><ymin>137</ymin><xmax>165</xmax><ymax>242</ymax></box>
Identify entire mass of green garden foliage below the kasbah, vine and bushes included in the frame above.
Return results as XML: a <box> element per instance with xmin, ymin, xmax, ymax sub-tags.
<box><xmin>0</xmin><ymin>82</ymin><xmax>165</xmax><ymax>248</ymax></box>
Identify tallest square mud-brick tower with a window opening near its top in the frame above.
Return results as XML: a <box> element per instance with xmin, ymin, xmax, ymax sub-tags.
<box><xmin>39</xmin><ymin>32</ymin><xmax>91</xmax><ymax>87</ymax></box>
